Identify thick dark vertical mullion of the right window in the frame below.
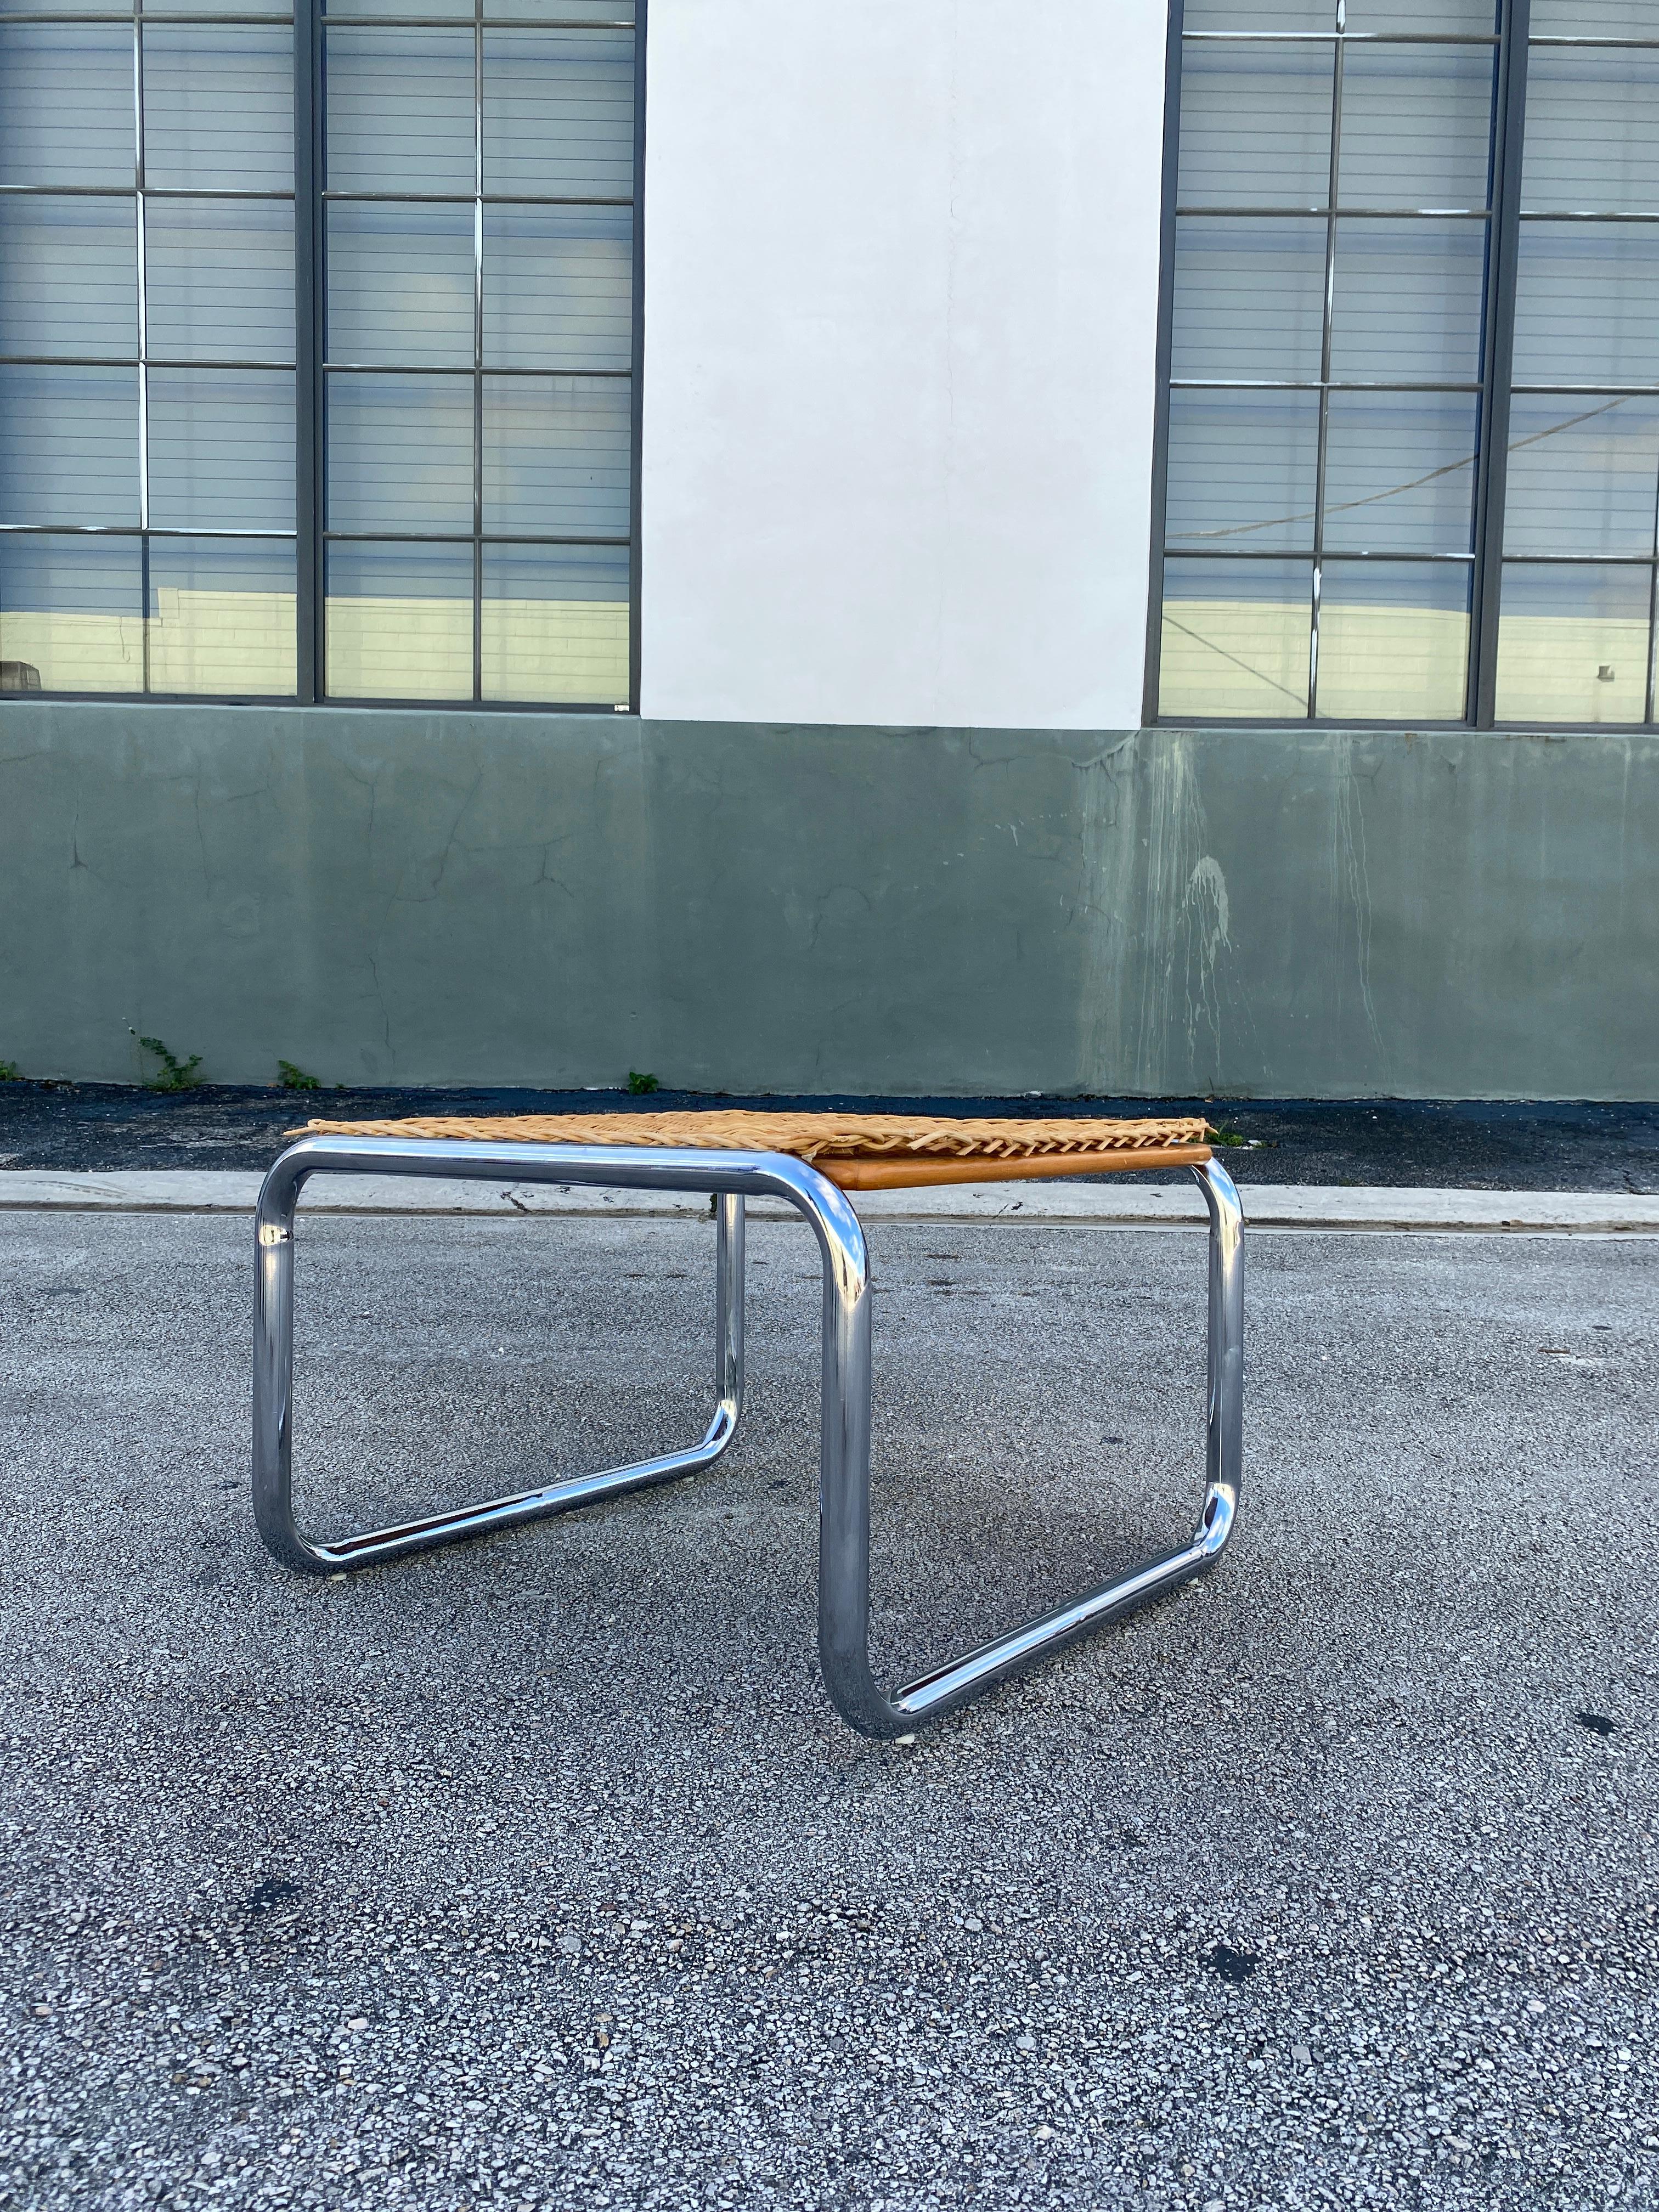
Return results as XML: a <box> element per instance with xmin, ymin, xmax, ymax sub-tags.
<box><xmin>1469</xmin><ymin>0</ymin><xmax>1531</xmax><ymax>730</ymax></box>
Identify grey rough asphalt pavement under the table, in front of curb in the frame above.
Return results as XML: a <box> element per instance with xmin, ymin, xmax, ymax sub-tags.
<box><xmin>0</xmin><ymin>1215</ymin><xmax>1659</xmax><ymax>2212</ymax></box>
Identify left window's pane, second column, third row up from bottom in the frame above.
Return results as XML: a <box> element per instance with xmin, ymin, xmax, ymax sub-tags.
<box><xmin>144</xmin><ymin>199</ymin><xmax>294</xmax><ymax>360</ymax></box>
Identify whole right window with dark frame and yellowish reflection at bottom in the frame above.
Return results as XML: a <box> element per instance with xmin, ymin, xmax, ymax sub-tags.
<box><xmin>1153</xmin><ymin>0</ymin><xmax>1659</xmax><ymax>725</ymax></box>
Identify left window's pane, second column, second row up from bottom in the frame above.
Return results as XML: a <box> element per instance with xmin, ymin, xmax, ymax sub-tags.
<box><xmin>150</xmin><ymin>369</ymin><xmax>294</xmax><ymax>533</ymax></box>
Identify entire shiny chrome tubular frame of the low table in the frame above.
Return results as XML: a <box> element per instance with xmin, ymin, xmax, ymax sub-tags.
<box><xmin>243</xmin><ymin>1137</ymin><xmax>1243</xmax><ymax>1736</ymax></box>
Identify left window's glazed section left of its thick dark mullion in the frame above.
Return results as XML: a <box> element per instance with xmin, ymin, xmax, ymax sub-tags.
<box><xmin>0</xmin><ymin>7</ymin><xmax>294</xmax><ymax>697</ymax></box>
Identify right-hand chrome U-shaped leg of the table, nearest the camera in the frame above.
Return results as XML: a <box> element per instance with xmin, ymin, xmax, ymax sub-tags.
<box><xmin>819</xmin><ymin>1161</ymin><xmax>1243</xmax><ymax>1736</ymax></box>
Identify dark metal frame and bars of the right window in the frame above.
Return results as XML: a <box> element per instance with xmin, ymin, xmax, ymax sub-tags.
<box><xmin>1144</xmin><ymin>0</ymin><xmax>1659</xmax><ymax>730</ymax></box>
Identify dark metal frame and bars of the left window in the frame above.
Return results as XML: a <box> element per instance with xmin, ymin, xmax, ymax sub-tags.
<box><xmin>0</xmin><ymin>0</ymin><xmax>648</xmax><ymax>714</ymax></box>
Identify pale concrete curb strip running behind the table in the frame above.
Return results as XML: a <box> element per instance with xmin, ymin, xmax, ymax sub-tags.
<box><xmin>0</xmin><ymin>1168</ymin><xmax>1659</xmax><ymax>1237</ymax></box>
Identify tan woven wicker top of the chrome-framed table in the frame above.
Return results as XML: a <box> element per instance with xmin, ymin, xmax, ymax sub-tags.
<box><xmin>294</xmin><ymin>1108</ymin><xmax>1210</xmax><ymax>1190</ymax></box>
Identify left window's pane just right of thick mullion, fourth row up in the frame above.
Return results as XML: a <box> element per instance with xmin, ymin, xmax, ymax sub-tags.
<box><xmin>328</xmin><ymin>31</ymin><xmax>478</xmax><ymax>193</ymax></box>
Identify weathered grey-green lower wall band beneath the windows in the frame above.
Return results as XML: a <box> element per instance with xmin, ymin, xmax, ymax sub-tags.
<box><xmin>0</xmin><ymin>701</ymin><xmax>1659</xmax><ymax>1099</ymax></box>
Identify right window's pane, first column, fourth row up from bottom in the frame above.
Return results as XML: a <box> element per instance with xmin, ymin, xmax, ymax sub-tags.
<box><xmin>1181</xmin><ymin>42</ymin><xmax>1334</xmax><ymax>208</ymax></box>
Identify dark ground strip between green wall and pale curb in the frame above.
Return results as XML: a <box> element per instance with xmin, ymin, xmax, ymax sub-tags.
<box><xmin>0</xmin><ymin>1082</ymin><xmax>1659</xmax><ymax>1192</ymax></box>
